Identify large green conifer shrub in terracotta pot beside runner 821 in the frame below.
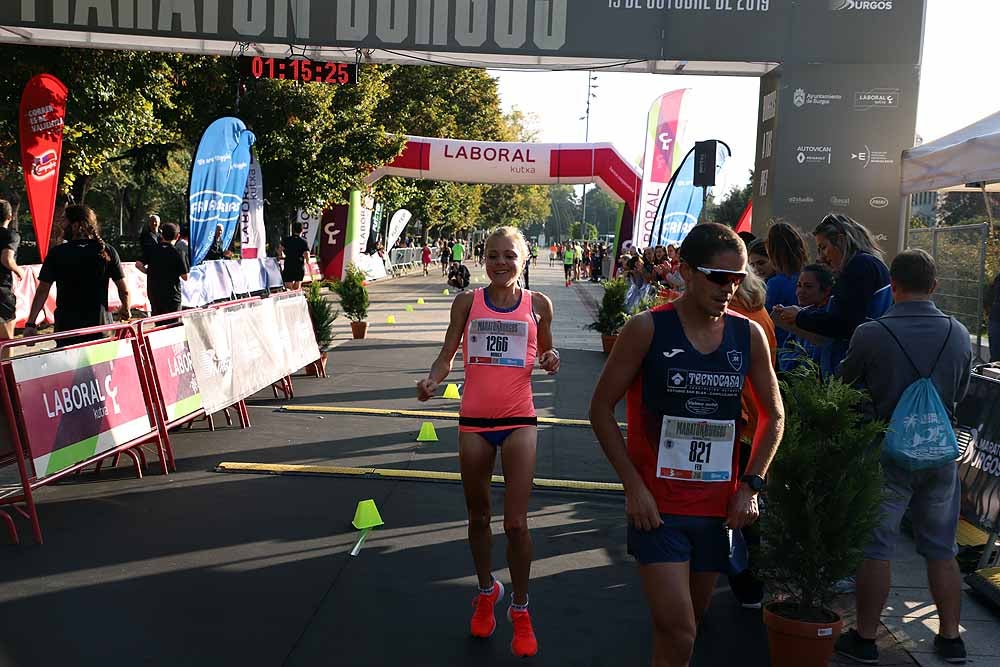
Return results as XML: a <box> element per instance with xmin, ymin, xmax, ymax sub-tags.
<box><xmin>757</xmin><ymin>359</ymin><xmax>885</xmax><ymax>667</ymax></box>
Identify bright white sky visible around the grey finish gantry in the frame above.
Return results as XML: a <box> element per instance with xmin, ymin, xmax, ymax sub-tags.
<box><xmin>492</xmin><ymin>0</ymin><xmax>1000</xmax><ymax>194</ymax></box>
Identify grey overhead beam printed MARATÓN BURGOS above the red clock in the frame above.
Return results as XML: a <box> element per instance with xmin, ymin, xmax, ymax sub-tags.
<box><xmin>0</xmin><ymin>0</ymin><xmax>924</xmax><ymax>70</ymax></box>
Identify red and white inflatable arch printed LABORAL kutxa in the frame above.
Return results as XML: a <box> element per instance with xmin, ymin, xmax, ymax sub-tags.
<box><xmin>365</xmin><ymin>136</ymin><xmax>642</xmax><ymax>249</ymax></box>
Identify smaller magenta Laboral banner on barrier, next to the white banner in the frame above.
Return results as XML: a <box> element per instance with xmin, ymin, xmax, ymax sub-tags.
<box><xmin>146</xmin><ymin>327</ymin><xmax>202</xmax><ymax>421</ymax></box>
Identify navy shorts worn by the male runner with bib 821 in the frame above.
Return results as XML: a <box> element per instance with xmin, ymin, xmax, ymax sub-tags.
<box><xmin>628</xmin><ymin>514</ymin><xmax>747</xmax><ymax>574</ymax></box>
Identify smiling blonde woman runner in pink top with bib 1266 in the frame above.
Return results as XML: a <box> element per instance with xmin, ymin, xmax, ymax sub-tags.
<box><xmin>417</xmin><ymin>227</ymin><xmax>559</xmax><ymax>656</ymax></box>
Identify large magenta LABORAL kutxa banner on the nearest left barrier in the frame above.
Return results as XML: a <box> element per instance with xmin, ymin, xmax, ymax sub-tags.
<box><xmin>11</xmin><ymin>340</ymin><xmax>153</xmax><ymax>478</ymax></box>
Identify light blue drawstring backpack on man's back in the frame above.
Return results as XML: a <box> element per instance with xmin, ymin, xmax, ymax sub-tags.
<box><xmin>875</xmin><ymin>317</ymin><xmax>959</xmax><ymax>471</ymax></box>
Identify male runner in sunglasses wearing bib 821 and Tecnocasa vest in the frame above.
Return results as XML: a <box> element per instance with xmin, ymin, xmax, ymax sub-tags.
<box><xmin>590</xmin><ymin>224</ymin><xmax>784</xmax><ymax>667</ymax></box>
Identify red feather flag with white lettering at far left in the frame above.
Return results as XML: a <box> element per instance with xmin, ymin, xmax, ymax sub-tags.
<box><xmin>19</xmin><ymin>74</ymin><xmax>69</xmax><ymax>260</ymax></box>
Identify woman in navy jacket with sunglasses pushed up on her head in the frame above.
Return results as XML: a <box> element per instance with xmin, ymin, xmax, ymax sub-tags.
<box><xmin>772</xmin><ymin>214</ymin><xmax>892</xmax><ymax>368</ymax></box>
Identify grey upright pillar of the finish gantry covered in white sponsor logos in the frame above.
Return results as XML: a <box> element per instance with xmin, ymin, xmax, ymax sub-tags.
<box><xmin>754</xmin><ymin>65</ymin><xmax>919</xmax><ymax>255</ymax></box>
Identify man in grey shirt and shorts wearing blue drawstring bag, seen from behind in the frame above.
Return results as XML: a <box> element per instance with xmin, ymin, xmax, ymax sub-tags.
<box><xmin>837</xmin><ymin>250</ymin><xmax>972</xmax><ymax>664</ymax></box>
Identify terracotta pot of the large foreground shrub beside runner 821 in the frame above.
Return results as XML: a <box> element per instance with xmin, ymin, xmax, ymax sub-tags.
<box><xmin>764</xmin><ymin>603</ymin><xmax>844</xmax><ymax>667</ymax></box>
